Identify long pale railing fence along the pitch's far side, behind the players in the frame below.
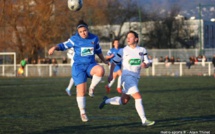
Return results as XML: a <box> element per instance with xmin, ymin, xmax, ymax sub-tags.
<box><xmin>0</xmin><ymin>62</ymin><xmax>214</xmax><ymax>77</ymax></box>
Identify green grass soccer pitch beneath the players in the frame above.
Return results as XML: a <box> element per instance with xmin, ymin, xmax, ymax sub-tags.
<box><xmin>0</xmin><ymin>76</ymin><xmax>215</xmax><ymax>134</ymax></box>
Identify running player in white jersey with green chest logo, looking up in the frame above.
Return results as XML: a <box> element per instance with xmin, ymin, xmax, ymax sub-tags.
<box><xmin>99</xmin><ymin>31</ymin><xmax>155</xmax><ymax>126</ymax></box>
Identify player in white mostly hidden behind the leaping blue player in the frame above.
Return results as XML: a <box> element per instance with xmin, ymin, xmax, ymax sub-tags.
<box><xmin>66</xmin><ymin>48</ymin><xmax>75</xmax><ymax>96</ymax></box>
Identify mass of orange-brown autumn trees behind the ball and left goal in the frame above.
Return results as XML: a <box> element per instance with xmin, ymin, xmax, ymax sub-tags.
<box><xmin>0</xmin><ymin>0</ymin><xmax>111</xmax><ymax>60</ymax></box>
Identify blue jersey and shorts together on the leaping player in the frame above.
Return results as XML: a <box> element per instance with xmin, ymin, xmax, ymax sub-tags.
<box><xmin>57</xmin><ymin>33</ymin><xmax>102</xmax><ymax>86</ymax></box>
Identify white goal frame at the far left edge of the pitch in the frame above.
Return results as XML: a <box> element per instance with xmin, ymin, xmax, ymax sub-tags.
<box><xmin>0</xmin><ymin>52</ymin><xmax>17</xmax><ymax>77</ymax></box>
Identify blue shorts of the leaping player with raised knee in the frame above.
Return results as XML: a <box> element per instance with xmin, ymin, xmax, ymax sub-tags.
<box><xmin>72</xmin><ymin>63</ymin><xmax>98</xmax><ymax>86</ymax></box>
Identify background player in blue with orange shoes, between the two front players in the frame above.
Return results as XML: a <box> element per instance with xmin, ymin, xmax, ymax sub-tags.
<box><xmin>105</xmin><ymin>39</ymin><xmax>122</xmax><ymax>93</ymax></box>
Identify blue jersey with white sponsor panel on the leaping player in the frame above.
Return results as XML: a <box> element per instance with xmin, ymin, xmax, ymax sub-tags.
<box><xmin>58</xmin><ymin>33</ymin><xmax>102</xmax><ymax>64</ymax></box>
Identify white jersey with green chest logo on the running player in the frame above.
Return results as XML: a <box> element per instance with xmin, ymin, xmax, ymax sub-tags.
<box><xmin>113</xmin><ymin>46</ymin><xmax>149</xmax><ymax>78</ymax></box>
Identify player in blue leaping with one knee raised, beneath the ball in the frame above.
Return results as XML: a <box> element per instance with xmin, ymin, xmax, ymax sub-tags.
<box><xmin>48</xmin><ymin>20</ymin><xmax>108</xmax><ymax>122</ymax></box>
